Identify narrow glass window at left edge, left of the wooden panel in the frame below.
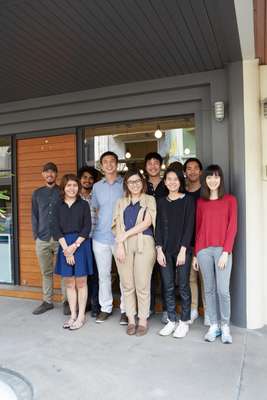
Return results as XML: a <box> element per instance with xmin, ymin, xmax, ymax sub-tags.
<box><xmin>0</xmin><ymin>137</ymin><xmax>13</xmax><ymax>283</ymax></box>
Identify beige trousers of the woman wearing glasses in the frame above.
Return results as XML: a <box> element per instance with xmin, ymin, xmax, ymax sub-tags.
<box><xmin>115</xmin><ymin>235</ymin><xmax>156</xmax><ymax>319</ymax></box>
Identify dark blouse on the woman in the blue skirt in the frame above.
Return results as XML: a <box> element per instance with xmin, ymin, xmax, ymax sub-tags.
<box><xmin>53</xmin><ymin>197</ymin><xmax>91</xmax><ymax>240</ymax></box>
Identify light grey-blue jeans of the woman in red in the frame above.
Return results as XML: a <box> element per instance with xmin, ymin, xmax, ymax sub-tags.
<box><xmin>197</xmin><ymin>246</ymin><xmax>232</xmax><ymax>324</ymax></box>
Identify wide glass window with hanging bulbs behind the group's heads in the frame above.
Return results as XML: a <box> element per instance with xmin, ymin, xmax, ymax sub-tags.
<box><xmin>84</xmin><ymin>115</ymin><xmax>196</xmax><ymax>171</ymax></box>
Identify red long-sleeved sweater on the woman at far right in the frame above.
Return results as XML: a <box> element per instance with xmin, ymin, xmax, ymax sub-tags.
<box><xmin>195</xmin><ymin>194</ymin><xmax>237</xmax><ymax>254</ymax></box>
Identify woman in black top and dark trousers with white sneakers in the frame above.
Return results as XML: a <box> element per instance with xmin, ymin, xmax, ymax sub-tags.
<box><xmin>156</xmin><ymin>168</ymin><xmax>195</xmax><ymax>338</ymax></box>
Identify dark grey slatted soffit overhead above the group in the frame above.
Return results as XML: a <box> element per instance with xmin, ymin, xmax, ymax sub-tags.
<box><xmin>0</xmin><ymin>0</ymin><xmax>241</xmax><ymax>103</ymax></box>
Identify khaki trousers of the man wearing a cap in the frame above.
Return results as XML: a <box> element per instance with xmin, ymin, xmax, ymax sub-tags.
<box><xmin>35</xmin><ymin>238</ymin><xmax>67</xmax><ymax>303</ymax></box>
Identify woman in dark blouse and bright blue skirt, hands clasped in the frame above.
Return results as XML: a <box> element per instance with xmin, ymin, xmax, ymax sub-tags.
<box><xmin>54</xmin><ymin>174</ymin><xmax>93</xmax><ymax>330</ymax></box>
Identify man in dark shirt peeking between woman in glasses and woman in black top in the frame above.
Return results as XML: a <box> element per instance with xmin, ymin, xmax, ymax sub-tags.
<box><xmin>145</xmin><ymin>152</ymin><xmax>168</xmax><ymax>324</ymax></box>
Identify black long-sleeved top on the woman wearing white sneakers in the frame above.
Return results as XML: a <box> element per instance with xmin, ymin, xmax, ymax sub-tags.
<box><xmin>155</xmin><ymin>194</ymin><xmax>195</xmax><ymax>254</ymax></box>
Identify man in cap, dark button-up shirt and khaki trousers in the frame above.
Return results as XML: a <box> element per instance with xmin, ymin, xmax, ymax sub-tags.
<box><xmin>32</xmin><ymin>162</ymin><xmax>69</xmax><ymax>315</ymax></box>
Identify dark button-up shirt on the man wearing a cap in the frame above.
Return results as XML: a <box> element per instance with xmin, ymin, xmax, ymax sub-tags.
<box><xmin>32</xmin><ymin>185</ymin><xmax>60</xmax><ymax>241</ymax></box>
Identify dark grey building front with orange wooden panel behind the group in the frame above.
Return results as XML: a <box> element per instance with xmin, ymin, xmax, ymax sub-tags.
<box><xmin>0</xmin><ymin>0</ymin><xmax>267</xmax><ymax>328</ymax></box>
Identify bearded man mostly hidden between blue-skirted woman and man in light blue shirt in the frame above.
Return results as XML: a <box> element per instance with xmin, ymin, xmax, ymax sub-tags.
<box><xmin>78</xmin><ymin>166</ymin><xmax>100</xmax><ymax>318</ymax></box>
